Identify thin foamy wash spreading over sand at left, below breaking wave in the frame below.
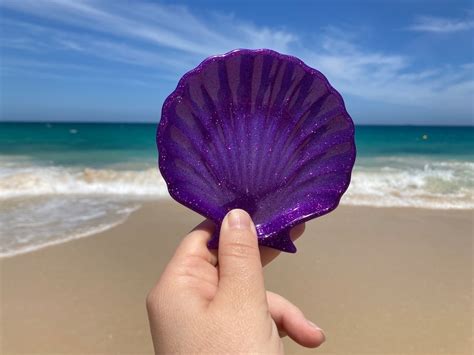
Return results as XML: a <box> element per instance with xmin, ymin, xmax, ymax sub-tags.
<box><xmin>0</xmin><ymin>195</ymin><xmax>140</xmax><ymax>257</ymax></box>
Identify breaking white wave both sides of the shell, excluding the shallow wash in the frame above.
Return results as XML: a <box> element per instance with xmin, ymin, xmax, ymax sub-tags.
<box><xmin>0</xmin><ymin>157</ymin><xmax>474</xmax><ymax>209</ymax></box>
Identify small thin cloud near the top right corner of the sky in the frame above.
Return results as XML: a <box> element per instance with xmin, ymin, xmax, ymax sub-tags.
<box><xmin>408</xmin><ymin>16</ymin><xmax>474</xmax><ymax>33</ymax></box>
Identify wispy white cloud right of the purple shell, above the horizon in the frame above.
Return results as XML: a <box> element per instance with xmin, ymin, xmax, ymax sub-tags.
<box><xmin>303</xmin><ymin>30</ymin><xmax>474</xmax><ymax>110</ymax></box>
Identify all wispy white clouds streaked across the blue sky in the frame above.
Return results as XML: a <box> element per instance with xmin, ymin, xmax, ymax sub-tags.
<box><xmin>0</xmin><ymin>0</ymin><xmax>474</xmax><ymax>121</ymax></box>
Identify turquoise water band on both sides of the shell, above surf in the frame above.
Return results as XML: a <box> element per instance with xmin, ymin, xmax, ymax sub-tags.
<box><xmin>0</xmin><ymin>123</ymin><xmax>474</xmax><ymax>167</ymax></box>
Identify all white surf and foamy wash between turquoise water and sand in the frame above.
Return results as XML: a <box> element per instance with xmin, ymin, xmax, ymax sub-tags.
<box><xmin>0</xmin><ymin>157</ymin><xmax>474</xmax><ymax>257</ymax></box>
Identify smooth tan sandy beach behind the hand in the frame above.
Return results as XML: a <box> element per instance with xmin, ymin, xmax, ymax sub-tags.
<box><xmin>0</xmin><ymin>201</ymin><xmax>473</xmax><ymax>354</ymax></box>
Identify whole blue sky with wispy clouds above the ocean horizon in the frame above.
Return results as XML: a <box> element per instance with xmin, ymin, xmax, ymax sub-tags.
<box><xmin>0</xmin><ymin>0</ymin><xmax>474</xmax><ymax>125</ymax></box>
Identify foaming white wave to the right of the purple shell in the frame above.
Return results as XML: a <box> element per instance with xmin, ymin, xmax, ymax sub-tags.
<box><xmin>342</xmin><ymin>162</ymin><xmax>474</xmax><ymax>209</ymax></box>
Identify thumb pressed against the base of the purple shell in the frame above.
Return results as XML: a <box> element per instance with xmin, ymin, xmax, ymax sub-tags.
<box><xmin>217</xmin><ymin>209</ymin><xmax>266</xmax><ymax>305</ymax></box>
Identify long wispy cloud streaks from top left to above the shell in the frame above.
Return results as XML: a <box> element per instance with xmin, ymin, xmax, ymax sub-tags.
<box><xmin>0</xmin><ymin>0</ymin><xmax>296</xmax><ymax>76</ymax></box>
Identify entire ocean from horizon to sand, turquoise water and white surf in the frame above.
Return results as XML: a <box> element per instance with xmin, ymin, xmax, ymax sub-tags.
<box><xmin>0</xmin><ymin>123</ymin><xmax>474</xmax><ymax>257</ymax></box>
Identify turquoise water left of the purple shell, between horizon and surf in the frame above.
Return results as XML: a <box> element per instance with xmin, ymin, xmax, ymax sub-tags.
<box><xmin>0</xmin><ymin>123</ymin><xmax>157</xmax><ymax>168</ymax></box>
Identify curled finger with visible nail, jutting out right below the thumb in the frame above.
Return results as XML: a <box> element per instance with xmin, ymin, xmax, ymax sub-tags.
<box><xmin>267</xmin><ymin>291</ymin><xmax>325</xmax><ymax>348</ymax></box>
